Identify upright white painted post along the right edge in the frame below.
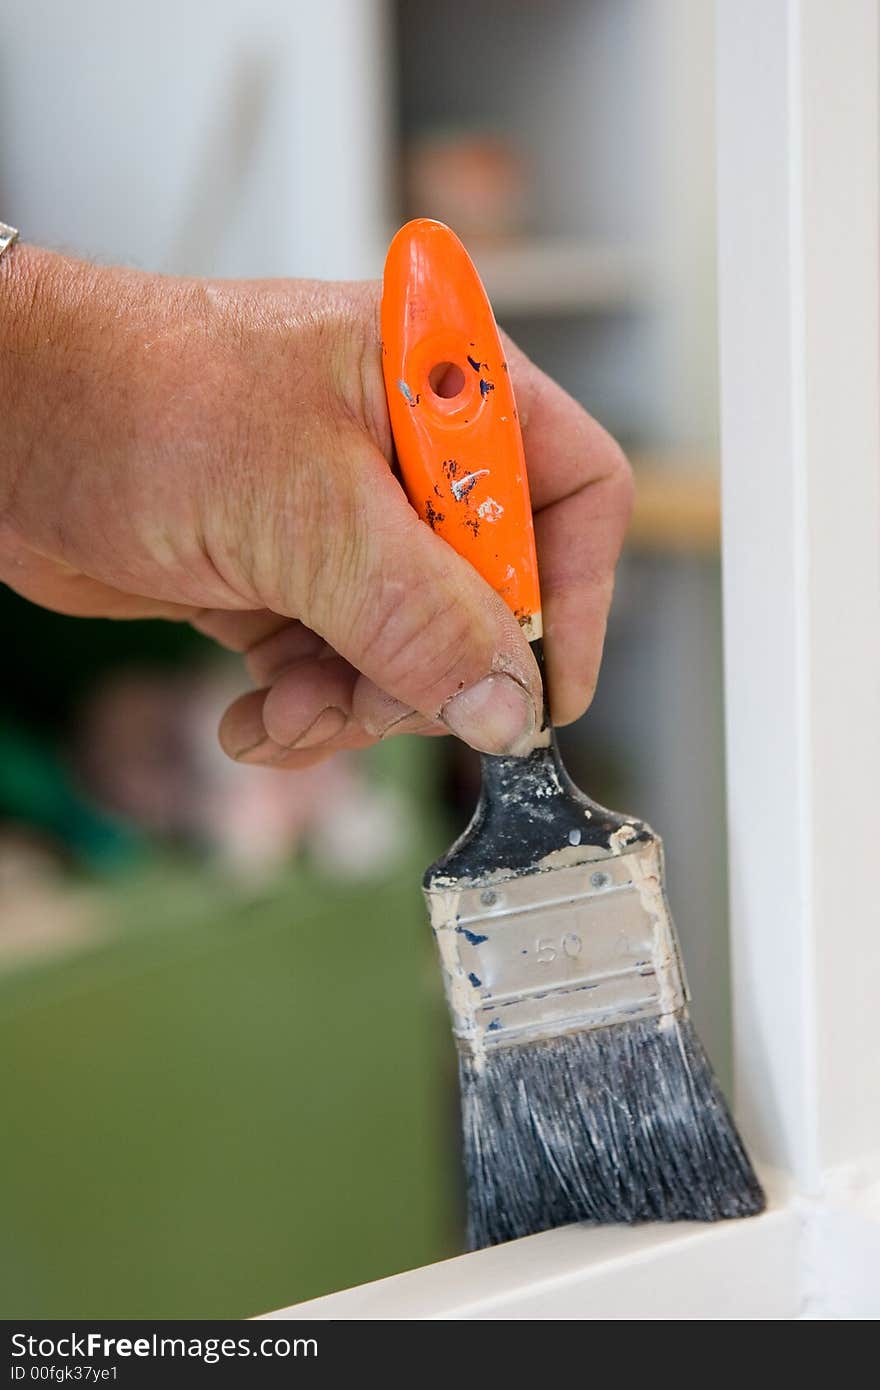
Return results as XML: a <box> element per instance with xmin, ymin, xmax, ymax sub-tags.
<box><xmin>719</xmin><ymin>0</ymin><xmax>880</xmax><ymax>1193</ymax></box>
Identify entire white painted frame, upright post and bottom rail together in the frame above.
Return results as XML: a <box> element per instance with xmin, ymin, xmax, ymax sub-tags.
<box><xmin>262</xmin><ymin>0</ymin><xmax>880</xmax><ymax>1319</ymax></box>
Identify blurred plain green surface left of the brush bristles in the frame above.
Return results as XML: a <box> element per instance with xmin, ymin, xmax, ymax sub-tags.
<box><xmin>0</xmin><ymin>845</ymin><xmax>457</xmax><ymax>1318</ymax></box>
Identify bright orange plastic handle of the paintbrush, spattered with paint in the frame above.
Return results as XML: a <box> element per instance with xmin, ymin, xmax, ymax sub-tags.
<box><xmin>382</xmin><ymin>217</ymin><xmax>541</xmax><ymax>641</ymax></box>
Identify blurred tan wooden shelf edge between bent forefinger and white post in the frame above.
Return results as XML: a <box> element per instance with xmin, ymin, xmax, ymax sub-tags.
<box><xmin>627</xmin><ymin>455</ymin><xmax>722</xmax><ymax>555</ymax></box>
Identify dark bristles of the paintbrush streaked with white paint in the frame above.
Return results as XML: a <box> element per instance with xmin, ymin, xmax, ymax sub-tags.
<box><xmin>460</xmin><ymin>1016</ymin><xmax>765</xmax><ymax>1250</ymax></box>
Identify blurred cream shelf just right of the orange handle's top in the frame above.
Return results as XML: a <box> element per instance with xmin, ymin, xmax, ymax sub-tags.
<box><xmin>470</xmin><ymin>239</ymin><xmax>651</xmax><ymax>317</ymax></box>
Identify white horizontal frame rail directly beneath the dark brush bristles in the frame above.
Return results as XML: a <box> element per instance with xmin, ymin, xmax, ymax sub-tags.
<box><xmin>262</xmin><ymin>1173</ymin><xmax>799</xmax><ymax>1321</ymax></box>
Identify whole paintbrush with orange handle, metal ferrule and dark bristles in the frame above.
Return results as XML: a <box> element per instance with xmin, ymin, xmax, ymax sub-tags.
<box><xmin>382</xmin><ymin>220</ymin><xmax>765</xmax><ymax>1248</ymax></box>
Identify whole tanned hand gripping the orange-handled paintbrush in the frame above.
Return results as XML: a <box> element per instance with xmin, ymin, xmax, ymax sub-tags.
<box><xmin>0</xmin><ymin>245</ymin><xmax>631</xmax><ymax>767</ymax></box>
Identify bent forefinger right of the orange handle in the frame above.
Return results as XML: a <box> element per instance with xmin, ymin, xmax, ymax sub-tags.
<box><xmin>507</xmin><ymin>343</ymin><xmax>633</xmax><ymax>724</ymax></box>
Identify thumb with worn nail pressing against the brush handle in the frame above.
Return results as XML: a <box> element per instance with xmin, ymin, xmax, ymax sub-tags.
<box><xmin>303</xmin><ymin>435</ymin><xmax>544</xmax><ymax>753</ymax></box>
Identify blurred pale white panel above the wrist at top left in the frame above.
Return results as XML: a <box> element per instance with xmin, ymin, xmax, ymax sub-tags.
<box><xmin>0</xmin><ymin>0</ymin><xmax>393</xmax><ymax>278</ymax></box>
